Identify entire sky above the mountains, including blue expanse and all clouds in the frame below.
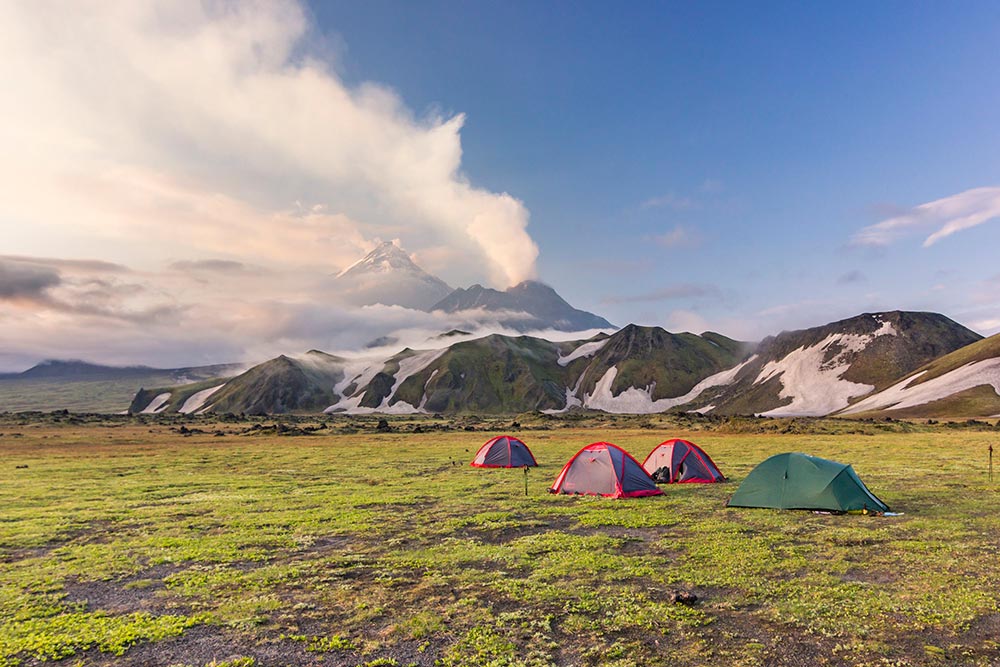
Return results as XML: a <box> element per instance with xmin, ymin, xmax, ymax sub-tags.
<box><xmin>0</xmin><ymin>0</ymin><xmax>1000</xmax><ymax>371</ymax></box>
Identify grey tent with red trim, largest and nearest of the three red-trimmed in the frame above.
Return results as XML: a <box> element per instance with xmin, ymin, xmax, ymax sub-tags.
<box><xmin>549</xmin><ymin>442</ymin><xmax>663</xmax><ymax>498</ymax></box>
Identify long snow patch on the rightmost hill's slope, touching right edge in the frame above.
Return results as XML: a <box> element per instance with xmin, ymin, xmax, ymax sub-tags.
<box><xmin>841</xmin><ymin>358</ymin><xmax>1000</xmax><ymax>415</ymax></box>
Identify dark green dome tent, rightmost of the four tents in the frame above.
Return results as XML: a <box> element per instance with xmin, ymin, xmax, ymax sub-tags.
<box><xmin>728</xmin><ymin>453</ymin><xmax>889</xmax><ymax>512</ymax></box>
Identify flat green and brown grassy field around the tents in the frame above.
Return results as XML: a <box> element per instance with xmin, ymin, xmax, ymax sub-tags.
<box><xmin>0</xmin><ymin>417</ymin><xmax>1000</xmax><ymax>667</ymax></box>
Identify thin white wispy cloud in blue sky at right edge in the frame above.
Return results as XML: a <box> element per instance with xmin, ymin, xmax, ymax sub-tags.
<box><xmin>852</xmin><ymin>187</ymin><xmax>1000</xmax><ymax>248</ymax></box>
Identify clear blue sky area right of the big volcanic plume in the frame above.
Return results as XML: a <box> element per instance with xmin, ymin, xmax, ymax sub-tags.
<box><xmin>312</xmin><ymin>2</ymin><xmax>1000</xmax><ymax>336</ymax></box>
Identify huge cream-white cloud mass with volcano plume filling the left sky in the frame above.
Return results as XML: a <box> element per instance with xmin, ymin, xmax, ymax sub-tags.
<box><xmin>0</xmin><ymin>0</ymin><xmax>538</xmax><ymax>370</ymax></box>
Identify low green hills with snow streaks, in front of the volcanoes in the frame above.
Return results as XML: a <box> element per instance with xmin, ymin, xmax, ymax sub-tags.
<box><xmin>115</xmin><ymin>311</ymin><xmax>1000</xmax><ymax>417</ymax></box>
